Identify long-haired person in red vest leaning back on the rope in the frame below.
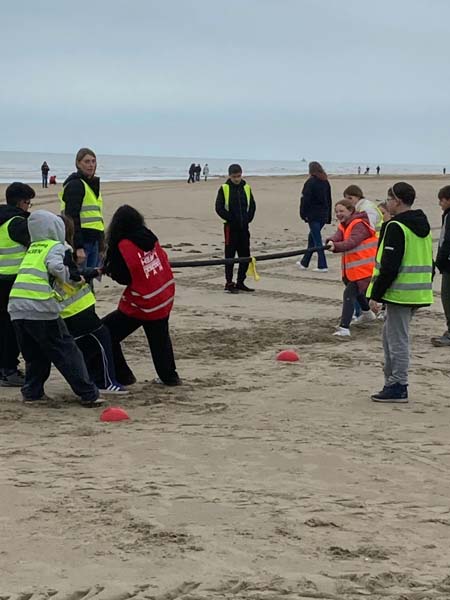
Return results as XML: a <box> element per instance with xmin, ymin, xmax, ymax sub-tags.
<box><xmin>103</xmin><ymin>204</ymin><xmax>181</xmax><ymax>385</ymax></box>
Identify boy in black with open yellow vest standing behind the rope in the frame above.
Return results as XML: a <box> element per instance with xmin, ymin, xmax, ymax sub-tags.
<box><xmin>216</xmin><ymin>164</ymin><xmax>256</xmax><ymax>294</ymax></box>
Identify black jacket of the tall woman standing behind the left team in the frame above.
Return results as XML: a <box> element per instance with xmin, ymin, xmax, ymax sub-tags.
<box><xmin>63</xmin><ymin>171</ymin><xmax>104</xmax><ymax>250</ymax></box>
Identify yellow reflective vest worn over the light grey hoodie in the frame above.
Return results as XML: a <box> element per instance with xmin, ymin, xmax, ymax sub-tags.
<box><xmin>10</xmin><ymin>240</ymin><xmax>60</xmax><ymax>301</ymax></box>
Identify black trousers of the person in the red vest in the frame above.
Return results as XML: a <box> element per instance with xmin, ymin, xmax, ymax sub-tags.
<box><xmin>103</xmin><ymin>310</ymin><xmax>178</xmax><ymax>385</ymax></box>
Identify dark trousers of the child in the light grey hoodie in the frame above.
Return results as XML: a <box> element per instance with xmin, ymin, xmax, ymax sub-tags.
<box><xmin>13</xmin><ymin>318</ymin><xmax>98</xmax><ymax>402</ymax></box>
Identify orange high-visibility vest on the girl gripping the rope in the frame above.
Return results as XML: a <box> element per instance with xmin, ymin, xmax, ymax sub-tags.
<box><xmin>339</xmin><ymin>219</ymin><xmax>378</xmax><ymax>281</ymax></box>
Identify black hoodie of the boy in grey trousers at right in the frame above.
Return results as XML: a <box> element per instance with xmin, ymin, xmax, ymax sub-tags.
<box><xmin>370</xmin><ymin>209</ymin><xmax>431</xmax><ymax>302</ymax></box>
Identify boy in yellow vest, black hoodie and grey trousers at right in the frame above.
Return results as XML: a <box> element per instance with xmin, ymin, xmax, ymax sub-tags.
<box><xmin>367</xmin><ymin>181</ymin><xmax>433</xmax><ymax>402</ymax></box>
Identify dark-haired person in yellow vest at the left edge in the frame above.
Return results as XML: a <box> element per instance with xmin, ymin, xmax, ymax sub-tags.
<box><xmin>0</xmin><ymin>182</ymin><xmax>35</xmax><ymax>387</ymax></box>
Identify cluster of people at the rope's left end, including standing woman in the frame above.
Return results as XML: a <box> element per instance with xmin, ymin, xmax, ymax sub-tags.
<box><xmin>0</xmin><ymin>148</ymin><xmax>181</xmax><ymax>406</ymax></box>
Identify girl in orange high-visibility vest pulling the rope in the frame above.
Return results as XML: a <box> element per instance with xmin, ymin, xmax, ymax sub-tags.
<box><xmin>326</xmin><ymin>199</ymin><xmax>378</xmax><ymax>338</ymax></box>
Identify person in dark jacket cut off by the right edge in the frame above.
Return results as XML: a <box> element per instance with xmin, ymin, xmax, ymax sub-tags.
<box><xmin>431</xmin><ymin>185</ymin><xmax>450</xmax><ymax>347</ymax></box>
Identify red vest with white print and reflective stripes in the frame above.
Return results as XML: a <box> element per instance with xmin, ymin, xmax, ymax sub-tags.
<box><xmin>119</xmin><ymin>240</ymin><xmax>175</xmax><ymax>321</ymax></box>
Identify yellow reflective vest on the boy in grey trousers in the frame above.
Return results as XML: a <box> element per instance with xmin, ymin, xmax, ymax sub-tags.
<box><xmin>367</xmin><ymin>221</ymin><xmax>433</xmax><ymax>304</ymax></box>
